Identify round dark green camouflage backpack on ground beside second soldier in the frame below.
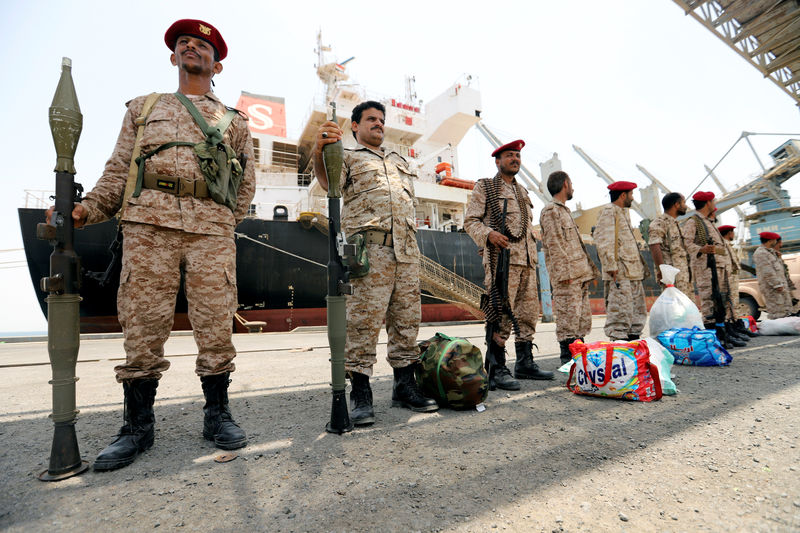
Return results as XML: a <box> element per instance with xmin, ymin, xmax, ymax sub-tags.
<box><xmin>417</xmin><ymin>333</ymin><xmax>489</xmax><ymax>409</ymax></box>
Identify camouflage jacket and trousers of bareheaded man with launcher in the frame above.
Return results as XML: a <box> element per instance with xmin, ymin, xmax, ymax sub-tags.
<box><xmin>342</xmin><ymin>145</ymin><xmax>421</xmax><ymax>376</ymax></box>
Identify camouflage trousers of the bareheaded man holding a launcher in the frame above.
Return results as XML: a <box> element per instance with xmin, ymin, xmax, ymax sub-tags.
<box><xmin>345</xmin><ymin>244</ymin><xmax>422</xmax><ymax>376</ymax></box>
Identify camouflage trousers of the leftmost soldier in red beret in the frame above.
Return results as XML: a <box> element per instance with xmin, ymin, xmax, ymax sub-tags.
<box><xmin>114</xmin><ymin>223</ymin><xmax>237</xmax><ymax>381</ymax></box>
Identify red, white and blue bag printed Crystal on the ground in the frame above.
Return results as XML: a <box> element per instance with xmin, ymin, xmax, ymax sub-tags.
<box><xmin>567</xmin><ymin>341</ymin><xmax>662</xmax><ymax>402</ymax></box>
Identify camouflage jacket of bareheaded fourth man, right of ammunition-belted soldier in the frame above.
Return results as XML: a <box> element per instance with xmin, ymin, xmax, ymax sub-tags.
<box><xmin>539</xmin><ymin>200</ymin><xmax>600</xmax><ymax>283</ymax></box>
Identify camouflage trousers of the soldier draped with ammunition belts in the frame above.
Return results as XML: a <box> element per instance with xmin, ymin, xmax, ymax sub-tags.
<box><xmin>483</xmin><ymin>264</ymin><xmax>539</xmax><ymax>344</ymax></box>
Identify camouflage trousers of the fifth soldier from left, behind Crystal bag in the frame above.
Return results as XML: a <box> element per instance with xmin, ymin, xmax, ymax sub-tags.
<box><xmin>603</xmin><ymin>279</ymin><xmax>647</xmax><ymax>340</ymax></box>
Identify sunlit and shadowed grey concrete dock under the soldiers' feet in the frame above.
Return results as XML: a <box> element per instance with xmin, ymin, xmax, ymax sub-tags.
<box><xmin>0</xmin><ymin>317</ymin><xmax>800</xmax><ymax>532</ymax></box>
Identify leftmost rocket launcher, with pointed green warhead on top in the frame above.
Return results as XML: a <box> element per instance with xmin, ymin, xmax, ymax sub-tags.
<box><xmin>36</xmin><ymin>57</ymin><xmax>89</xmax><ymax>481</ymax></box>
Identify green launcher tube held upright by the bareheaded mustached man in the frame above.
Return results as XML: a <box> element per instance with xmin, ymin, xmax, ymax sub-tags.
<box><xmin>322</xmin><ymin>102</ymin><xmax>355</xmax><ymax>435</ymax></box>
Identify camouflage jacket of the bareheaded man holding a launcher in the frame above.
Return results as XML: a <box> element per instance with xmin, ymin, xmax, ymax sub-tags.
<box><xmin>334</xmin><ymin>145</ymin><xmax>419</xmax><ymax>263</ymax></box>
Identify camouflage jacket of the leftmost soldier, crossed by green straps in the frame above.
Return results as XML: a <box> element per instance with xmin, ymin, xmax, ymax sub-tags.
<box><xmin>81</xmin><ymin>92</ymin><xmax>255</xmax><ymax>237</ymax></box>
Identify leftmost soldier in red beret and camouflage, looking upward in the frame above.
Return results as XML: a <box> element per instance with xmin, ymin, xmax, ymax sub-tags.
<box><xmin>48</xmin><ymin>19</ymin><xmax>255</xmax><ymax>470</ymax></box>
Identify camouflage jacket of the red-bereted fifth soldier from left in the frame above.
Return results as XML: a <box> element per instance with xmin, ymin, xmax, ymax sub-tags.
<box><xmin>594</xmin><ymin>203</ymin><xmax>650</xmax><ymax>280</ymax></box>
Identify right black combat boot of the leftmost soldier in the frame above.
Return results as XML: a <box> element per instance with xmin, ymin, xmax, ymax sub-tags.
<box><xmin>200</xmin><ymin>372</ymin><xmax>247</xmax><ymax>450</ymax></box>
